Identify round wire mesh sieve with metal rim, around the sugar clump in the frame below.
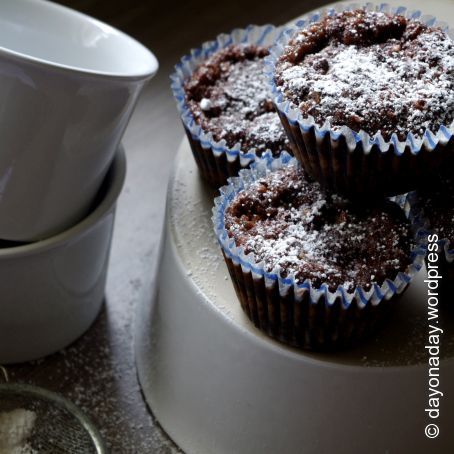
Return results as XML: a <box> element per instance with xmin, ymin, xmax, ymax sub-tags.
<box><xmin>0</xmin><ymin>384</ymin><xmax>106</xmax><ymax>454</ymax></box>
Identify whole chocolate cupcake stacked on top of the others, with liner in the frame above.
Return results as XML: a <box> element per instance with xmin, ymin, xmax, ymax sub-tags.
<box><xmin>267</xmin><ymin>5</ymin><xmax>454</xmax><ymax>197</ymax></box>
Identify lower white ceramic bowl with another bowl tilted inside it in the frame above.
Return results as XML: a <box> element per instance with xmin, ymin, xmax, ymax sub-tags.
<box><xmin>0</xmin><ymin>147</ymin><xmax>126</xmax><ymax>364</ymax></box>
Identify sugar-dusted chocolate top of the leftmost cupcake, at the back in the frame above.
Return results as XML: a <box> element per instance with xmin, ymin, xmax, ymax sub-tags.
<box><xmin>184</xmin><ymin>44</ymin><xmax>288</xmax><ymax>156</ymax></box>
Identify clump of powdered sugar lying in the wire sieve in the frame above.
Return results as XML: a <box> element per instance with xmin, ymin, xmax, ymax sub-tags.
<box><xmin>0</xmin><ymin>408</ymin><xmax>36</xmax><ymax>454</ymax></box>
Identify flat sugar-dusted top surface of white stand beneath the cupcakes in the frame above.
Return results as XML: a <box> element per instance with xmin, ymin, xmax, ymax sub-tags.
<box><xmin>167</xmin><ymin>139</ymin><xmax>454</xmax><ymax>367</ymax></box>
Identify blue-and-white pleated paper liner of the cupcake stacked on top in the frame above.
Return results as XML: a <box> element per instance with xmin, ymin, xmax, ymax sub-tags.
<box><xmin>266</xmin><ymin>3</ymin><xmax>454</xmax><ymax>197</ymax></box>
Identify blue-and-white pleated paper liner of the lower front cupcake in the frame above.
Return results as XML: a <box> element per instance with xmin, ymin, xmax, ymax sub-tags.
<box><xmin>212</xmin><ymin>152</ymin><xmax>427</xmax><ymax>349</ymax></box>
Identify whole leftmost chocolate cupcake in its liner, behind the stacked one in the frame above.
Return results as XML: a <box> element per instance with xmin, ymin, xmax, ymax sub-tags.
<box><xmin>172</xmin><ymin>25</ymin><xmax>289</xmax><ymax>187</ymax></box>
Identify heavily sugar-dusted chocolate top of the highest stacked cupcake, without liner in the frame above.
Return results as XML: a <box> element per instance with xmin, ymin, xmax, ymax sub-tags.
<box><xmin>275</xmin><ymin>9</ymin><xmax>454</xmax><ymax>140</ymax></box>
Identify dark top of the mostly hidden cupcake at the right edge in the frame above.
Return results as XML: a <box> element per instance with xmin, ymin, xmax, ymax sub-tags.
<box><xmin>418</xmin><ymin>179</ymin><xmax>454</xmax><ymax>250</ymax></box>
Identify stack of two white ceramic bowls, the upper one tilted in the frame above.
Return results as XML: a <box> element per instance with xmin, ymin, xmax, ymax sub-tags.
<box><xmin>0</xmin><ymin>0</ymin><xmax>158</xmax><ymax>363</ymax></box>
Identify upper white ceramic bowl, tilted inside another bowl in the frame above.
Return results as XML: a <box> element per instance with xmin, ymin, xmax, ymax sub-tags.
<box><xmin>0</xmin><ymin>0</ymin><xmax>158</xmax><ymax>241</ymax></box>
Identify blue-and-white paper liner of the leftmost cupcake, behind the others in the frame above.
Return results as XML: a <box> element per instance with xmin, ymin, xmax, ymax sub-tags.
<box><xmin>170</xmin><ymin>25</ymin><xmax>288</xmax><ymax>188</ymax></box>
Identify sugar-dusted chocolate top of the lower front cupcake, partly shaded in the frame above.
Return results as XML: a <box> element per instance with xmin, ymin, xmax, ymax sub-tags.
<box><xmin>224</xmin><ymin>167</ymin><xmax>414</xmax><ymax>292</ymax></box>
